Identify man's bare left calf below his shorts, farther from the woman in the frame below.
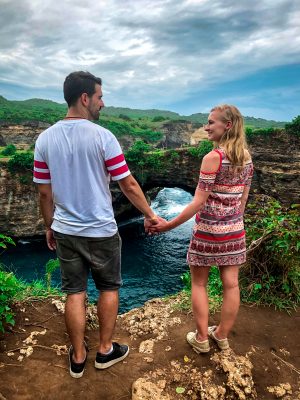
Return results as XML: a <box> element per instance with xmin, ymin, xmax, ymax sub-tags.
<box><xmin>65</xmin><ymin>291</ymin><xmax>86</xmax><ymax>363</ymax></box>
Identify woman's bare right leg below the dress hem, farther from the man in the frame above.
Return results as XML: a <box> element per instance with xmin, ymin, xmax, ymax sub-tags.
<box><xmin>215</xmin><ymin>265</ymin><xmax>240</xmax><ymax>339</ymax></box>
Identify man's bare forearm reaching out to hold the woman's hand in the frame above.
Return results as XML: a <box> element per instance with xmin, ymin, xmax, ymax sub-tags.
<box><xmin>118</xmin><ymin>175</ymin><xmax>157</xmax><ymax>225</ymax></box>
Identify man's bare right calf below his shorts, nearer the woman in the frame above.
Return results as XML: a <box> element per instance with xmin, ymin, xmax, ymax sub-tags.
<box><xmin>97</xmin><ymin>290</ymin><xmax>119</xmax><ymax>354</ymax></box>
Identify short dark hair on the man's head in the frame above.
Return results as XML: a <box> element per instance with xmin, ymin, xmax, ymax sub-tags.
<box><xmin>64</xmin><ymin>71</ymin><xmax>102</xmax><ymax>107</ymax></box>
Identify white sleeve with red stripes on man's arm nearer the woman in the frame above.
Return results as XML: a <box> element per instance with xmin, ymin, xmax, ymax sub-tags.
<box><xmin>105</xmin><ymin>136</ymin><xmax>130</xmax><ymax>181</ymax></box>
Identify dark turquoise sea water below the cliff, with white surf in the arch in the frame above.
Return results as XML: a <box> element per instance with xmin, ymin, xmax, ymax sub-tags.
<box><xmin>0</xmin><ymin>188</ymin><xmax>193</xmax><ymax>312</ymax></box>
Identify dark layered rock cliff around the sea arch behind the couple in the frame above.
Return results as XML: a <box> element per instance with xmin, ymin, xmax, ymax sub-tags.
<box><xmin>0</xmin><ymin>132</ymin><xmax>300</xmax><ymax>237</ymax></box>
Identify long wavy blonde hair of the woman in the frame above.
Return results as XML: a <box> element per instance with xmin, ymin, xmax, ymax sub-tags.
<box><xmin>211</xmin><ymin>104</ymin><xmax>249</xmax><ymax>169</ymax></box>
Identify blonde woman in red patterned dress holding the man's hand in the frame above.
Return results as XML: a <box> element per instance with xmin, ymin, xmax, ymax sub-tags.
<box><xmin>150</xmin><ymin>104</ymin><xmax>253</xmax><ymax>353</ymax></box>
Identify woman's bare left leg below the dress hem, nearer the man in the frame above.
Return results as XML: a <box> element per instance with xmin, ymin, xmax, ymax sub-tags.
<box><xmin>190</xmin><ymin>266</ymin><xmax>210</xmax><ymax>342</ymax></box>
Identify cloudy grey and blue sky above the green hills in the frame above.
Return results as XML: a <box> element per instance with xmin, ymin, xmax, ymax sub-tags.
<box><xmin>0</xmin><ymin>0</ymin><xmax>300</xmax><ymax>121</ymax></box>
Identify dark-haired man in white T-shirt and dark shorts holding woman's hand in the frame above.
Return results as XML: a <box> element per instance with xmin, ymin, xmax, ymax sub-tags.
<box><xmin>33</xmin><ymin>71</ymin><xmax>157</xmax><ymax>378</ymax></box>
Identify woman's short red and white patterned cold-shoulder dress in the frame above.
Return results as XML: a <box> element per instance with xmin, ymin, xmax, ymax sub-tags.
<box><xmin>187</xmin><ymin>148</ymin><xmax>253</xmax><ymax>267</ymax></box>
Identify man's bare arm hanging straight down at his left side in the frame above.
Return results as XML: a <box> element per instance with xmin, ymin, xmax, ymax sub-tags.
<box><xmin>38</xmin><ymin>183</ymin><xmax>56</xmax><ymax>250</ymax></box>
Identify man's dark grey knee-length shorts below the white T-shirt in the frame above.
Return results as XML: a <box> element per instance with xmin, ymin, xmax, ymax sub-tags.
<box><xmin>54</xmin><ymin>232</ymin><xmax>122</xmax><ymax>293</ymax></box>
